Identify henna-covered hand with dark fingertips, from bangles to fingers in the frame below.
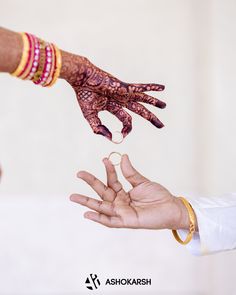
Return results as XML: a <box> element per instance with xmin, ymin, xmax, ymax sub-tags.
<box><xmin>61</xmin><ymin>51</ymin><xmax>166</xmax><ymax>140</ymax></box>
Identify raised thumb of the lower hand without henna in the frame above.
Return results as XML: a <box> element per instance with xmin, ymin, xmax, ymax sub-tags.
<box><xmin>121</xmin><ymin>155</ymin><xmax>149</xmax><ymax>187</ymax></box>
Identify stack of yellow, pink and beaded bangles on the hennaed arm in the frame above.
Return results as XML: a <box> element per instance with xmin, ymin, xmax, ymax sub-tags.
<box><xmin>11</xmin><ymin>33</ymin><xmax>62</xmax><ymax>87</ymax></box>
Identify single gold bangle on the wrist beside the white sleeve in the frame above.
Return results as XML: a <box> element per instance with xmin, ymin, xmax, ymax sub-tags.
<box><xmin>172</xmin><ymin>197</ymin><xmax>196</xmax><ymax>245</ymax></box>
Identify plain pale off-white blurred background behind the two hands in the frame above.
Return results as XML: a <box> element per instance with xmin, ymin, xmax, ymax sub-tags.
<box><xmin>0</xmin><ymin>0</ymin><xmax>236</xmax><ymax>295</ymax></box>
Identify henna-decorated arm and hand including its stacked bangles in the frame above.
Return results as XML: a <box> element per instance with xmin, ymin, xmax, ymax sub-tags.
<box><xmin>0</xmin><ymin>28</ymin><xmax>166</xmax><ymax>140</ymax></box>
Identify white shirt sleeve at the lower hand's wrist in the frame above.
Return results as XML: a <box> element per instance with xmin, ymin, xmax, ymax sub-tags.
<box><xmin>180</xmin><ymin>194</ymin><xmax>236</xmax><ymax>255</ymax></box>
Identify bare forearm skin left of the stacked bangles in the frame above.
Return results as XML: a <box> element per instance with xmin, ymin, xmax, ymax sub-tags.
<box><xmin>0</xmin><ymin>27</ymin><xmax>23</xmax><ymax>73</ymax></box>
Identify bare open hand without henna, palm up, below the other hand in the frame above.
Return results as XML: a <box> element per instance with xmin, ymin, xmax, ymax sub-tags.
<box><xmin>70</xmin><ymin>155</ymin><xmax>189</xmax><ymax>229</ymax></box>
